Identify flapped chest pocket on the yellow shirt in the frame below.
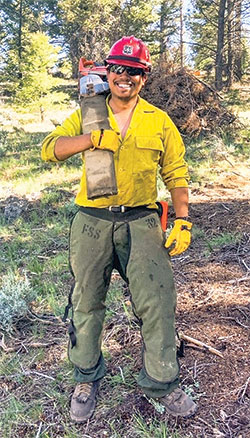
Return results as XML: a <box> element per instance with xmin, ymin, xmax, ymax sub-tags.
<box><xmin>133</xmin><ymin>137</ymin><xmax>164</xmax><ymax>173</ymax></box>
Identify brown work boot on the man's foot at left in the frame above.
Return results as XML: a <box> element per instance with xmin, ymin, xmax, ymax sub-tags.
<box><xmin>70</xmin><ymin>381</ymin><xmax>99</xmax><ymax>423</ymax></box>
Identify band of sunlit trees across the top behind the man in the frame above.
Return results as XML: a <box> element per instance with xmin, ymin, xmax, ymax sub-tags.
<box><xmin>0</xmin><ymin>0</ymin><xmax>250</xmax><ymax>104</ymax></box>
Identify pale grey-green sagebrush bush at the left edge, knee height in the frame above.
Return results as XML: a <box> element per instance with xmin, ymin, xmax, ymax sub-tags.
<box><xmin>0</xmin><ymin>272</ymin><xmax>36</xmax><ymax>331</ymax></box>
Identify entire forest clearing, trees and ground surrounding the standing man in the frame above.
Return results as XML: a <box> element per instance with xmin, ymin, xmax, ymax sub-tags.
<box><xmin>0</xmin><ymin>0</ymin><xmax>250</xmax><ymax>438</ymax></box>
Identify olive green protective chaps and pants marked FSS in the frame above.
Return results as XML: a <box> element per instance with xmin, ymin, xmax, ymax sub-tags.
<box><xmin>69</xmin><ymin>208</ymin><xmax>179</xmax><ymax>397</ymax></box>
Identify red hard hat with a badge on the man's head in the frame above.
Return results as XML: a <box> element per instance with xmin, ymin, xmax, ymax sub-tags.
<box><xmin>105</xmin><ymin>35</ymin><xmax>151</xmax><ymax>71</ymax></box>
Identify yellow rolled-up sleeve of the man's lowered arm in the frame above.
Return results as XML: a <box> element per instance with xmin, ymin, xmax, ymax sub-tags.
<box><xmin>160</xmin><ymin>118</ymin><xmax>189</xmax><ymax>191</ymax></box>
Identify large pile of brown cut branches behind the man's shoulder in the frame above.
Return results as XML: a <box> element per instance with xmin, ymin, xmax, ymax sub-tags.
<box><xmin>141</xmin><ymin>68</ymin><xmax>236</xmax><ymax>137</ymax></box>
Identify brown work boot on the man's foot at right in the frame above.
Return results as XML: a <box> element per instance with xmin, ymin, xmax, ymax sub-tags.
<box><xmin>157</xmin><ymin>388</ymin><xmax>197</xmax><ymax>417</ymax></box>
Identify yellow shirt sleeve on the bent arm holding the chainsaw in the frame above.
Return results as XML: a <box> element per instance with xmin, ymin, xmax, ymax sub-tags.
<box><xmin>41</xmin><ymin>109</ymin><xmax>82</xmax><ymax>161</ymax></box>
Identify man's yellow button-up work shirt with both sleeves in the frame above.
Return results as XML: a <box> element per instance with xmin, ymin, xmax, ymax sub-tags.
<box><xmin>42</xmin><ymin>98</ymin><xmax>189</xmax><ymax>208</ymax></box>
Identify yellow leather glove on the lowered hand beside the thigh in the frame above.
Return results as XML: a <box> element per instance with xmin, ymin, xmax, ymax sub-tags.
<box><xmin>165</xmin><ymin>219</ymin><xmax>192</xmax><ymax>256</ymax></box>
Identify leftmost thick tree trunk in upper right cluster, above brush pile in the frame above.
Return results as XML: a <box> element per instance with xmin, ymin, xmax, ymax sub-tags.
<box><xmin>215</xmin><ymin>0</ymin><xmax>226</xmax><ymax>90</ymax></box>
